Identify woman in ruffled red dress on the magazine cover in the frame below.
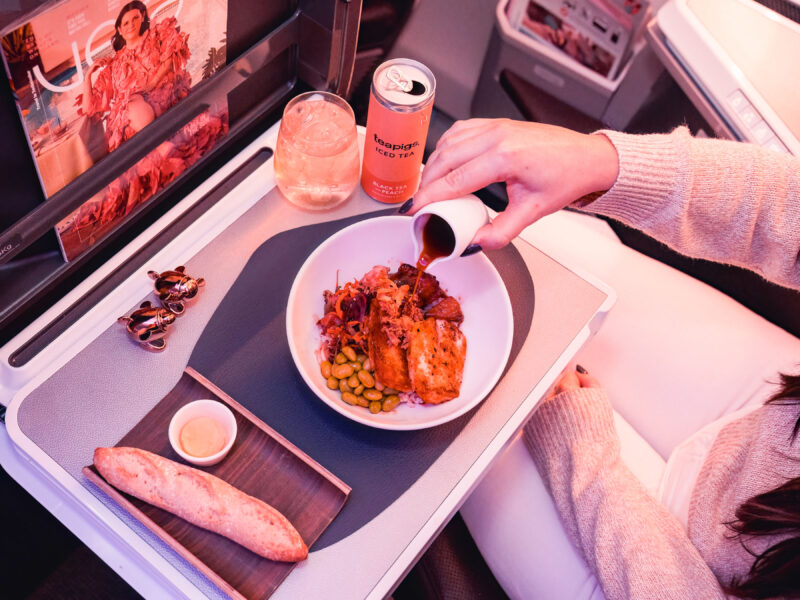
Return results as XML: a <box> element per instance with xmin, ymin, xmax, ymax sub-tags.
<box><xmin>57</xmin><ymin>0</ymin><xmax>228</xmax><ymax>260</ymax></box>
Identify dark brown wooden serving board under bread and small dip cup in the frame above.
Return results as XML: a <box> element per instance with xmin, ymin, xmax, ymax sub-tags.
<box><xmin>83</xmin><ymin>367</ymin><xmax>350</xmax><ymax>600</ymax></box>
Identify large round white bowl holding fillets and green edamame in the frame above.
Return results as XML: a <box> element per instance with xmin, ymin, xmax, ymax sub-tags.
<box><xmin>286</xmin><ymin>216</ymin><xmax>514</xmax><ymax>430</ymax></box>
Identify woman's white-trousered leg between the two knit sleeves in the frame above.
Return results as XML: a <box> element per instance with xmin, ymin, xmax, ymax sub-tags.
<box><xmin>522</xmin><ymin>211</ymin><xmax>800</xmax><ymax>458</ymax></box>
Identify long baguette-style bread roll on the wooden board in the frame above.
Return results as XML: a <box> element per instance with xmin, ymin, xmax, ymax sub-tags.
<box><xmin>94</xmin><ymin>447</ymin><xmax>308</xmax><ymax>562</ymax></box>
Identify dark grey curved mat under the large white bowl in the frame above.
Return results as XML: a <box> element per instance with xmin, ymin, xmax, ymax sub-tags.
<box><xmin>189</xmin><ymin>211</ymin><xmax>534</xmax><ymax>549</ymax></box>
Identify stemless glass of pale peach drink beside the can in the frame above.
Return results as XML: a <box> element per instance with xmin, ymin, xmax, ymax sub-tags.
<box><xmin>275</xmin><ymin>92</ymin><xmax>361</xmax><ymax>210</ymax></box>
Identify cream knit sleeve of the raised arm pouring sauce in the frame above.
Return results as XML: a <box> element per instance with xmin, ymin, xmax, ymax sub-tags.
<box><xmin>585</xmin><ymin>127</ymin><xmax>800</xmax><ymax>289</ymax></box>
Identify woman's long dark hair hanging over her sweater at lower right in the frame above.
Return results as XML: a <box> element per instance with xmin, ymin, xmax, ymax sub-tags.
<box><xmin>725</xmin><ymin>374</ymin><xmax>800</xmax><ymax>598</ymax></box>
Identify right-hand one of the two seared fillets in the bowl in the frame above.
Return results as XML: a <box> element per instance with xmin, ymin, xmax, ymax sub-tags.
<box><xmin>407</xmin><ymin>318</ymin><xmax>467</xmax><ymax>404</ymax></box>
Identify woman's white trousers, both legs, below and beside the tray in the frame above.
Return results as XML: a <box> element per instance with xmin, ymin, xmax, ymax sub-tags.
<box><xmin>461</xmin><ymin>210</ymin><xmax>800</xmax><ymax>598</ymax></box>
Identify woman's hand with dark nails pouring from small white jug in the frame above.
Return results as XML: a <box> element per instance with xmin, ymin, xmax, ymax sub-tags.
<box><xmin>409</xmin><ymin>119</ymin><xmax>619</xmax><ymax>250</ymax></box>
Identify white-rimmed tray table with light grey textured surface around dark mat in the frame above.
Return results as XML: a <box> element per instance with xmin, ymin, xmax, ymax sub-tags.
<box><xmin>0</xmin><ymin>123</ymin><xmax>615</xmax><ymax>600</ymax></box>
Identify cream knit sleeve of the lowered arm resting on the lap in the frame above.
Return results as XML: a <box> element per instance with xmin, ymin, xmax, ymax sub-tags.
<box><xmin>525</xmin><ymin>388</ymin><xmax>725</xmax><ymax>600</ymax></box>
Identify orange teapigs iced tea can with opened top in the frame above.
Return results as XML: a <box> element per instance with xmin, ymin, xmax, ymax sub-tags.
<box><xmin>361</xmin><ymin>58</ymin><xmax>436</xmax><ymax>203</ymax></box>
